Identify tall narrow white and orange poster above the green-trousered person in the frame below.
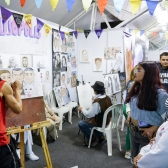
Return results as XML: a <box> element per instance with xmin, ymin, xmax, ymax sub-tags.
<box><xmin>124</xmin><ymin>33</ymin><xmax>133</xmax><ymax>82</ymax></box>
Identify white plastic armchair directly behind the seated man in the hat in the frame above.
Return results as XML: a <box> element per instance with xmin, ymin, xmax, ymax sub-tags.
<box><xmin>88</xmin><ymin>104</ymin><xmax>123</xmax><ymax>156</ymax></box>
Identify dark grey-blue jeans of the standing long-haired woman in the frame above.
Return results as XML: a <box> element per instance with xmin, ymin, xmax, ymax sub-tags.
<box><xmin>130</xmin><ymin>129</ymin><xmax>150</xmax><ymax>159</ymax></box>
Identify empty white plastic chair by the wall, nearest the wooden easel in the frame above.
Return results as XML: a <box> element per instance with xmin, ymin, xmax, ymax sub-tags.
<box><xmin>47</xmin><ymin>90</ymin><xmax>72</xmax><ymax>130</ymax></box>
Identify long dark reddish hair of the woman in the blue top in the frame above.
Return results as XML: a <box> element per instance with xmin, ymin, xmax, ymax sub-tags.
<box><xmin>126</xmin><ymin>62</ymin><xmax>163</xmax><ymax>111</ymax></box>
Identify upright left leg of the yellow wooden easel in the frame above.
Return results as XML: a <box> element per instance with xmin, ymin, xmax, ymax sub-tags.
<box><xmin>20</xmin><ymin>132</ymin><xmax>25</xmax><ymax>168</ymax></box>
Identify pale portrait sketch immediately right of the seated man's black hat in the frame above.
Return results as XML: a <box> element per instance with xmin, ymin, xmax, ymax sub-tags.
<box><xmin>104</xmin><ymin>74</ymin><xmax>113</xmax><ymax>96</ymax></box>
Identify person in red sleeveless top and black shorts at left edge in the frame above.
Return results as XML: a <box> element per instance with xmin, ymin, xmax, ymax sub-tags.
<box><xmin>0</xmin><ymin>79</ymin><xmax>22</xmax><ymax>168</ymax></box>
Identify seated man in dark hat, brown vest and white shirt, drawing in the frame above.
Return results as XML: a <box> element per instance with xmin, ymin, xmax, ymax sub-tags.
<box><xmin>78</xmin><ymin>81</ymin><xmax>112</xmax><ymax>146</ymax></box>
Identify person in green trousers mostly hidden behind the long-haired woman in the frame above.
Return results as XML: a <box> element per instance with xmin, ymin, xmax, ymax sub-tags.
<box><xmin>123</xmin><ymin>69</ymin><xmax>134</xmax><ymax>159</ymax></box>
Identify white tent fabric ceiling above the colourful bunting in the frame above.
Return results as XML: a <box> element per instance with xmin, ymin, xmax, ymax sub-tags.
<box><xmin>0</xmin><ymin>0</ymin><xmax>168</xmax><ymax>49</ymax></box>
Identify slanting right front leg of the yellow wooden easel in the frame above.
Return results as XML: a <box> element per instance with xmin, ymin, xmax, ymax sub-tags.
<box><xmin>39</xmin><ymin>127</ymin><xmax>53</xmax><ymax>168</ymax></box>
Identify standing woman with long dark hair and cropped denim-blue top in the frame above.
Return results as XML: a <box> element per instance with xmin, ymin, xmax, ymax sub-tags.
<box><xmin>126</xmin><ymin>62</ymin><xmax>168</xmax><ymax>159</ymax></box>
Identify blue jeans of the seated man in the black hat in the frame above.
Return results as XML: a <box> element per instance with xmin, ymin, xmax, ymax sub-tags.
<box><xmin>78</xmin><ymin>120</ymin><xmax>103</xmax><ymax>139</ymax></box>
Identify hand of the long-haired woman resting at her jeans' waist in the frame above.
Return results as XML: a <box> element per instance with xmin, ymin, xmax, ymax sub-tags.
<box><xmin>141</xmin><ymin>126</ymin><xmax>158</xmax><ymax>140</ymax></box>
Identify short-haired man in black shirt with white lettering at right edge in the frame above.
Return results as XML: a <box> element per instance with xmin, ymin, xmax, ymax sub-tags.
<box><xmin>156</xmin><ymin>52</ymin><xmax>168</xmax><ymax>92</ymax></box>
